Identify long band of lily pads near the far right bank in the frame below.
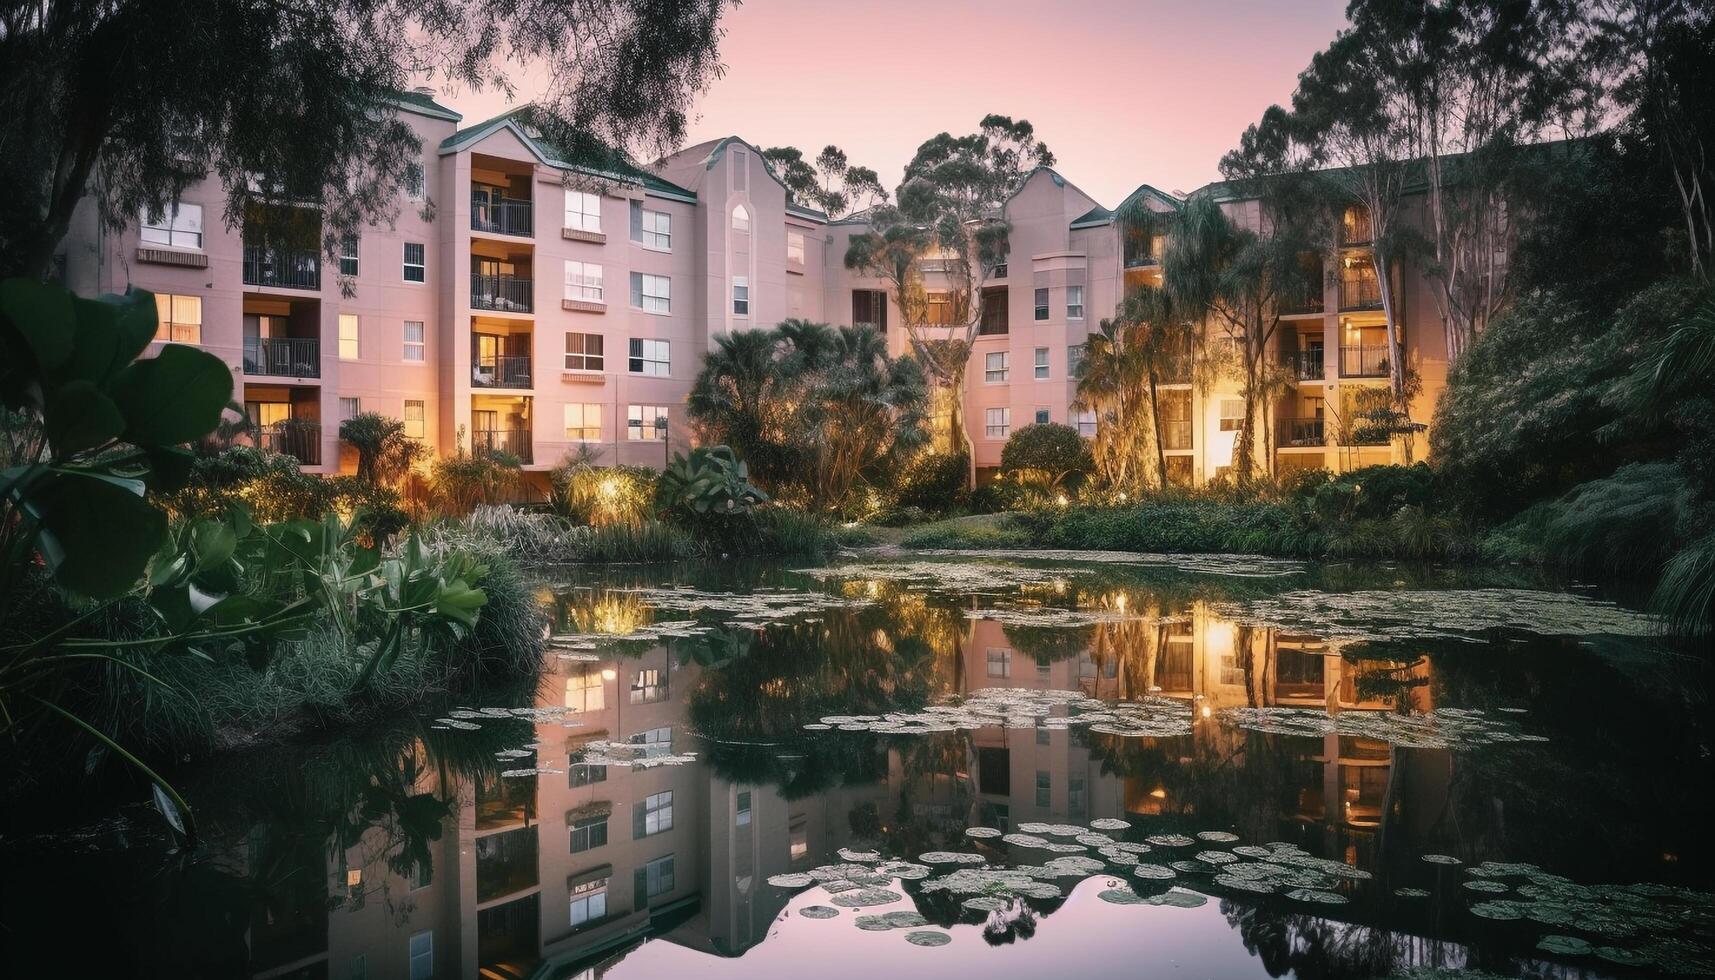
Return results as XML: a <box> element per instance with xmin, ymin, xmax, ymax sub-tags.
<box><xmin>1213</xmin><ymin>589</ymin><xmax>1655</xmax><ymax>642</ymax></box>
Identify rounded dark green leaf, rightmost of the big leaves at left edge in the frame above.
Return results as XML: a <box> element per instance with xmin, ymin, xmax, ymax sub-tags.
<box><xmin>113</xmin><ymin>343</ymin><xmax>232</xmax><ymax>446</ymax></box>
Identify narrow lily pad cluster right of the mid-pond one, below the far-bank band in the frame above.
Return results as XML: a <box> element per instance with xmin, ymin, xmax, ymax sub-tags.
<box><xmin>1221</xmin><ymin>707</ymin><xmax>1549</xmax><ymax>748</ymax></box>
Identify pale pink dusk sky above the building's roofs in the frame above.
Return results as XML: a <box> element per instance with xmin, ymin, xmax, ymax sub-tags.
<box><xmin>448</xmin><ymin>0</ymin><xmax>1346</xmax><ymax>206</ymax></box>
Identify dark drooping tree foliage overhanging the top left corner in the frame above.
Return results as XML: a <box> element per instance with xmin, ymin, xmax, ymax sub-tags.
<box><xmin>0</xmin><ymin>0</ymin><xmax>727</xmax><ymax>278</ymax></box>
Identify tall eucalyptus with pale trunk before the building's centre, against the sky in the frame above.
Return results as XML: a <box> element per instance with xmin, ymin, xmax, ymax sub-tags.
<box><xmin>845</xmin><ymin>115</ymin><xmax>1055</xmax><ymax>486</ymax></box>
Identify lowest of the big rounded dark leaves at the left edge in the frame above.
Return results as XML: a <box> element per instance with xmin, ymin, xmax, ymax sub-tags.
<box><xmin>27</xmin><ymin>470</ymin><xmax>166</xmax><ymax>599</ymax></box>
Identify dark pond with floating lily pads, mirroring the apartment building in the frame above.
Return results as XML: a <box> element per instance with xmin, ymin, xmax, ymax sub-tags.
<box><xmin>0</xmin><ymin>553</ymin><xmax>1715</xmax><ymax>980</ymax></box>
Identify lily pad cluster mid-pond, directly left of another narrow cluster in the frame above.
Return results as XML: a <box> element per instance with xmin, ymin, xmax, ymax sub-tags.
<box><xmin>804</xmin><ymin>688</ymin><xmax>1190</xmax><ymax>738</ymax></box>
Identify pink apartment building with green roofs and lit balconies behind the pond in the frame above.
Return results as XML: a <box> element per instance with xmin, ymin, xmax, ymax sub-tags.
<box><xmin>65</xmin><ymin>93</ymin><xmax>1446</xmax><ymax>482</ymax></box>
